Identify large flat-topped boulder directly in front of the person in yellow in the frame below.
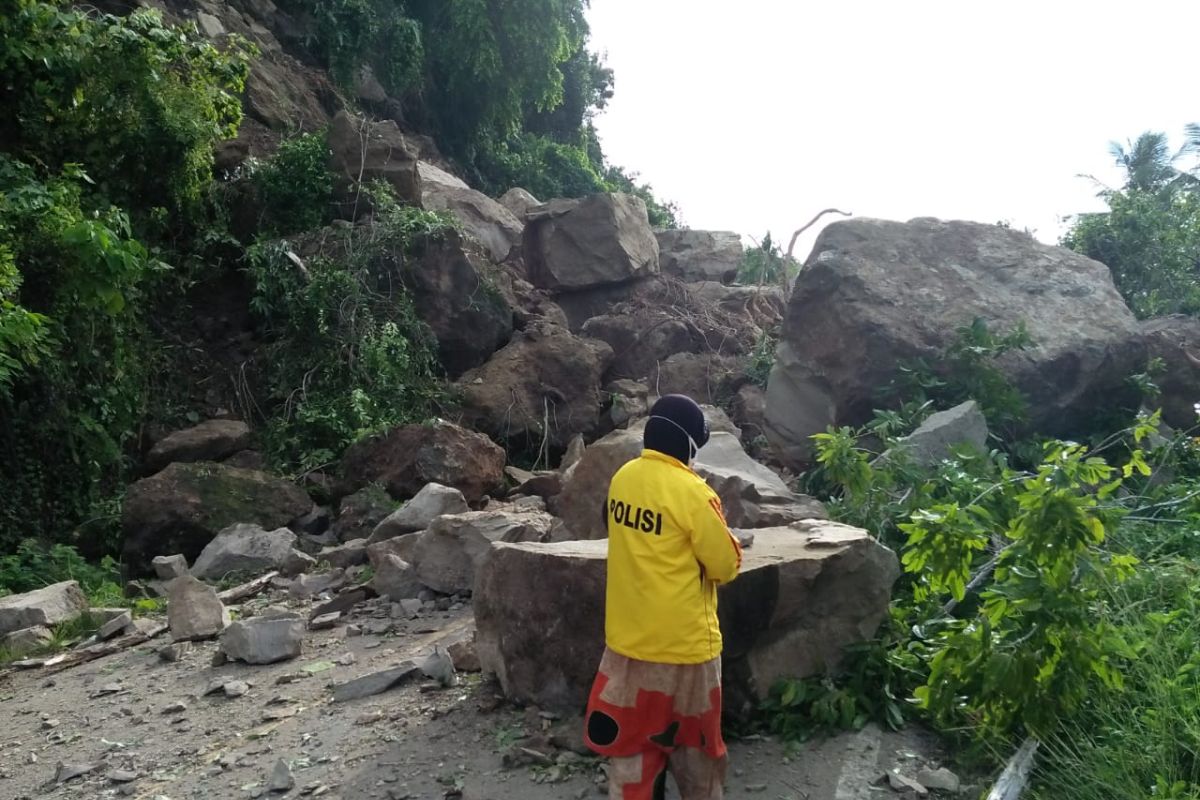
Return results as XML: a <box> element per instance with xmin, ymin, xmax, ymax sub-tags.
<box><xmin>474</xmin><ymin>521</ymin><xmax>900</xmax><ymax>715</ymax></box>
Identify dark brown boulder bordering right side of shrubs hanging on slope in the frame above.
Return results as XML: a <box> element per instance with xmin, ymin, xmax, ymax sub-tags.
<box><xmin>400</xmin><ymin>231</ymin><xmax>512</xmax><ymax>377</ymax></box>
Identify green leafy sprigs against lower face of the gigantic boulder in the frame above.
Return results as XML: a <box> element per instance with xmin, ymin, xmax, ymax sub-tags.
<box><xmin>886</xmin><ymin>318</ymin><xmax>1033</xmax><ymax>440</ymax></box>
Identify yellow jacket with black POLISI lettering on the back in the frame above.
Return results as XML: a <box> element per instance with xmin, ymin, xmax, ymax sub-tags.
<box><xmin>605</xmin><ymin>450</ymin><xmax>742</xmax><ymax>664</ymax></box>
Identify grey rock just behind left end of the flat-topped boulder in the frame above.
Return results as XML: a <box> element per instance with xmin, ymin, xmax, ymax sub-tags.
<box><xmin>412</xmin><ymin>511</ymin><xmax>553</xmax><ymax>595</ymax></box>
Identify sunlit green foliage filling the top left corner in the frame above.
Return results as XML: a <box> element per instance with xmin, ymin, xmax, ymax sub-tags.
<box><xmin>0</xmin><ymin>0</ymin><xmax>250</xmax><ymax>214</ymax></box>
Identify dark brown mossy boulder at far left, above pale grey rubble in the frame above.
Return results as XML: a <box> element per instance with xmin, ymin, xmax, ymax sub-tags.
<box><xmin>121</xmin><ymin>462</ymin><xmax>312</xmax><ymax>572</ymax></box>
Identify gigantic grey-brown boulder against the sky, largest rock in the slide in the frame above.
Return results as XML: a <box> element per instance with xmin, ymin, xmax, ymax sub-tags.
<box><xmin>767</xmin><ymin>219</ymin><xmax>1146</xmax><ymax>465</ymax></box>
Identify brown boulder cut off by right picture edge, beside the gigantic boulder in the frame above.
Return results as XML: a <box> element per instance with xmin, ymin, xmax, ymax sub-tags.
<box><xmin>1141</xmin><ymin>314</ymin><xmax>1200</xmax><ymax>431</ymax></box>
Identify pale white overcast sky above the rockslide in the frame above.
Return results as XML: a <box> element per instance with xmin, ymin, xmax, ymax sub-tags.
<box><xmin>588</xmin><ymin>0</ymin><xmax>1200</xmax><ymax>258</ymax></box>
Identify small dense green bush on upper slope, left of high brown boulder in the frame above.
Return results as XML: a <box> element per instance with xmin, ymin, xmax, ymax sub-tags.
<box><xmin>247</xmin><ymin>133</ymin><xmax>334</xmax><ymax>235</ymax></box>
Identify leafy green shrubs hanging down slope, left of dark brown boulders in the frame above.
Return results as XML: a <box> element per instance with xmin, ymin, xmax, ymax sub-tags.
<box><xmin>248</xmin><ymin>207</ymin><xmax>450</xmax><ymax>469</ymax></box>
